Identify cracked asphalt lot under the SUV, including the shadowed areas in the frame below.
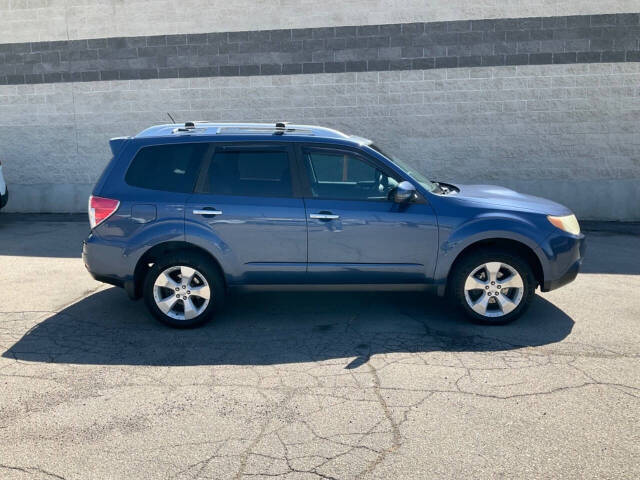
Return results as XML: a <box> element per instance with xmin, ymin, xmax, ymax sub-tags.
<box><xmin>0</xmin><ymin>215</ymin><xmax>640</xmax><ymax>479</ymax></box>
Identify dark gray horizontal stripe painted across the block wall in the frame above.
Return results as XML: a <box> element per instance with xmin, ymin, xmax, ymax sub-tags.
<box><xmin>0</xmin><ymin>13</ymin><xmax>640</xmax><ymax>85</ymax></box>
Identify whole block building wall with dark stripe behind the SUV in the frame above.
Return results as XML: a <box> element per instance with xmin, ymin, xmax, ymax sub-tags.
<box><xmin>0</xmin><ymin>0</ymin><xmax>640</xmax><ymax>220</ymax></box>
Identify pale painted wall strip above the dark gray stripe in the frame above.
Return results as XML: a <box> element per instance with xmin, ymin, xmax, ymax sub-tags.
<box><xmin>0</xmin><ymin>0</ymin><xmax>640</xmax><ymax>43</ymax></box>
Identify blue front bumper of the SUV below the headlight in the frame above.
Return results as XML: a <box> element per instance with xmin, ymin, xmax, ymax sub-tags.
<box><xmin>541</xmin><ymin>233</ymin><xmax>586</xmax><ymax>292</ymax></box>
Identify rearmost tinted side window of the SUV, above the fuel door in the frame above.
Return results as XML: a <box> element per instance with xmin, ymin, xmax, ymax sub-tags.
<box><xmin>125</xmin><ymin>143</ymin><xmax>208</xmax><ymax>193</ymax></box>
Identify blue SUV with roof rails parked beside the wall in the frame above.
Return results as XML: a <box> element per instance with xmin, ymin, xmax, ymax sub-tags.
<box><xmin>83</xmin><ymin>122</ymin><xmax>584</xmax><ymax>327</ymax></box>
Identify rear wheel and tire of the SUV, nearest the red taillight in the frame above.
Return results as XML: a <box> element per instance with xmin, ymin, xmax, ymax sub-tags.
<box><xmin>143</xmin><ymin>252</ymin><xmax>225</xmax><ymax>328</ymax></box>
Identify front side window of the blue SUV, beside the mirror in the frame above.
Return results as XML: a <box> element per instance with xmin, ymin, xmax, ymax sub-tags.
<box><xmin>304</xmin><ymin>150</ymin><xmax>399</xmax><ymax>200</ymax></box>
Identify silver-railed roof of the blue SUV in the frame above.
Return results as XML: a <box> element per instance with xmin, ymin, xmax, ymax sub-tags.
<box><xmin>134</xmin><ymin>122</ymin><xmax>371</xmax><ymax>145</ymax></box>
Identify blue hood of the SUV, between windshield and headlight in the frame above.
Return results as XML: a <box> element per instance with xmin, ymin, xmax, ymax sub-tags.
<box><xmin>454</xmin><ymin>184</ymin><xmax>571</xmax><ymax>215</ymax></box>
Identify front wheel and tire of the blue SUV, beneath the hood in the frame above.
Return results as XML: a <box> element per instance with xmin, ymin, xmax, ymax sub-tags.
<box><xmin>450</xmin><ymin>249</ymin><xmax>537</xmax><ymax>325</ymax></box>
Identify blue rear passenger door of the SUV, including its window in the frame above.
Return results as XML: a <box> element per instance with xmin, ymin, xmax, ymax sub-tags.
<box><xmin>185</xmin><ymin>143</ymin><xmax>307</xmax><ymax>284</ymax></box>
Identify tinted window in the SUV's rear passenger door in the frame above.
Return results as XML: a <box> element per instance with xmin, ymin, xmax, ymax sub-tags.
<box><xmin>208</xmin><ymin>150</ymin><xmax>292</xmax><ymax>197</ymax></box>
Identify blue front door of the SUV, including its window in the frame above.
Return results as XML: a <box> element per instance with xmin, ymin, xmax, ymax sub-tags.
<box><xmin>302</xmin><ymin>147</ymin><xmax>438</xmax><ymax>283</ymax></box>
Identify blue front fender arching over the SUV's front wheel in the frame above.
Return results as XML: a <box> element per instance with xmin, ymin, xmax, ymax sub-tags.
<box><xmin>434</xmin><ymin>212</ymin><xmax>549</xmax><ymax>294</ymax></box>
